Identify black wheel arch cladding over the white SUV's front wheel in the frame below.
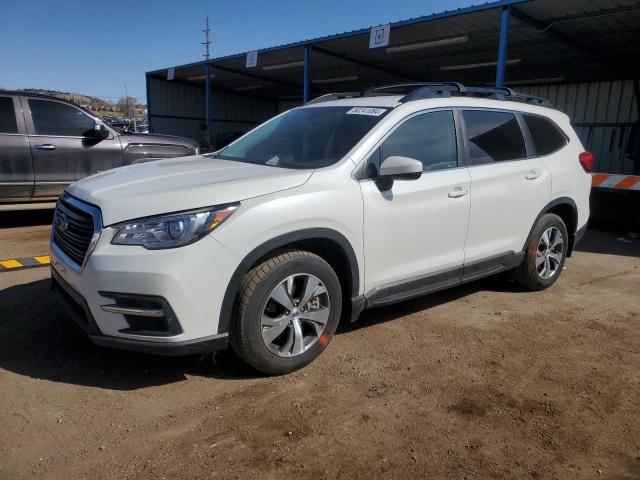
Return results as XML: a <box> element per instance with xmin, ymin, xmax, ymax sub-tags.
<box><xmin>218</xmin><ymin>228</ymin><xmax>360</xmax><ymax>333</ymax></box>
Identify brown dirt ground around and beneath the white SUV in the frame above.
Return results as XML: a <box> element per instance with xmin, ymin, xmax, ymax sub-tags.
<box><xmin>0</xmin><ymin>212</ymin><xmax>640</xmax><ymax>480</ymax></box>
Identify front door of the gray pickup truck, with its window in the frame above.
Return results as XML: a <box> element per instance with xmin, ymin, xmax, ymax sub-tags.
<box><xmin>22</xmin><ymin>97</ymin><xmax>122</xmax><ymax>198</ymax></box>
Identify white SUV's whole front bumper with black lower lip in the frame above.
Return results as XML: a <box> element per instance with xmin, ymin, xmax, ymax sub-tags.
<box><xmin>51</xmin><ymin>218</ymin><xmax>239</xmax><ymax>355</ymax></box>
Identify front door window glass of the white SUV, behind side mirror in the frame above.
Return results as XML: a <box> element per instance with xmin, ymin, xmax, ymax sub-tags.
<box><xmin>367</xmin><ymin>111</ymin><xmax>458</xmax><ymax>177</ymax></box>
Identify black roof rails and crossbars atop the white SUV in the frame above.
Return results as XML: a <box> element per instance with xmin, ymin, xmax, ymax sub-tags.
<box><xmin>306</xmin><ymin>82</ymin><xmax>553</xmax><ymax>107</ymax></box>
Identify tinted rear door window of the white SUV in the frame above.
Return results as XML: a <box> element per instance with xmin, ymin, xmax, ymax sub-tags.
<box><xmin>462</xmin><ymin>110</ymin><xmax>527</xmax><ymax>165</ymax></box>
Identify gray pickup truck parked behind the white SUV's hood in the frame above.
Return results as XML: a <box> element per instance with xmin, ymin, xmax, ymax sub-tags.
<box><xmin>0</xmin><ymin>91</ymin><xmax>198</xmax><ymax>203</ymax></box>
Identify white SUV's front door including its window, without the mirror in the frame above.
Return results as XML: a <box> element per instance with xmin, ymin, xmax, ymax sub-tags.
<box><xmin>360</xmin><ymin>110</ymin><xmax>470</xmax><ymax>296</ymax></box>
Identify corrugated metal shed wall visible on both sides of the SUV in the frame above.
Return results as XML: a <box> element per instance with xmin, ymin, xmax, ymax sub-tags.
<box><xmin>149</xmin><ymin>78</ymin><xmax>638</xmax><ymax>173</ymax></box>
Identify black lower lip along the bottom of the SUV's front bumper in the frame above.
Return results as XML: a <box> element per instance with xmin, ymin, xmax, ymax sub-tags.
<box><xmin>51</xmin><ymin>267</ymin><xmax>229</xmax><ymax>355</ymax></box>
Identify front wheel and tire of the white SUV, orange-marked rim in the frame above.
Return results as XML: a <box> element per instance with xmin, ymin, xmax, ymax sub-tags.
<box><xmin>231</xmin><ymin>250</ymin><xmax>342</xmax><ymax>375</ymax></box>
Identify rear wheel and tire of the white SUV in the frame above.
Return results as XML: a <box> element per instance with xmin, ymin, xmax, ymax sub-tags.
<box><xmin>513</xmin><ymin>213</ymin><xmax>569</xmax><ymax>291</ymax></box>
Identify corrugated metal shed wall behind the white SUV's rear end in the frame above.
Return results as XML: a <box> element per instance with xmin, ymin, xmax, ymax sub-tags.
<box><xmin>517</xmin><ymin>80</ymin><xmax>638</xmax><ymax>173</ymax></box>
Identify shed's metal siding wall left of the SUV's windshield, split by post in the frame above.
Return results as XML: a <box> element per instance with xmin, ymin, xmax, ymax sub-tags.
<box><xmin>149</xmin><ymin>78</ymin><xmax>277</xmax><ymax>145</ymax></box>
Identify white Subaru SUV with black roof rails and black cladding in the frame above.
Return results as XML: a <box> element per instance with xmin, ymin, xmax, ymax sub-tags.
<box><xmin>51</xmin><ymin>84</ymin><xmax>592</xmax><ymax>374</ymax></box>
